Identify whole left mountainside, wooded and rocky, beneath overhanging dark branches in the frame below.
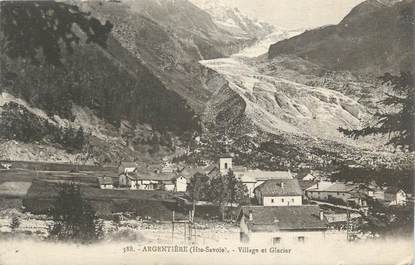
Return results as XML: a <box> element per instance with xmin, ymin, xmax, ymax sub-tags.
<box><xmin>0</xmin><ymin>0</ymin><xmax>272</xmax><ymax>163</ymax></box>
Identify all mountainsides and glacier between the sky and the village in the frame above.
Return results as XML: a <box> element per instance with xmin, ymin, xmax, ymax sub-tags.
<box><xmin>0</xmin><ymin>0</ymin><xmax>414</xmax><ymax>169</ymax></box>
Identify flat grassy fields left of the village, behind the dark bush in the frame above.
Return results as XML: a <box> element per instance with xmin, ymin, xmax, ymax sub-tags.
<box><xmin>0</xmin><ymin>163</ymin><xmax>223</xmax><ymax>221</ymax></box>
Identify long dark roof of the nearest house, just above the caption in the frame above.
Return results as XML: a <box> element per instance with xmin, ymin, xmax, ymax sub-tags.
<box><xmin>238</xmin><ymin>205</ymin><xmax>327</xmax><ymax>232</ymax></box>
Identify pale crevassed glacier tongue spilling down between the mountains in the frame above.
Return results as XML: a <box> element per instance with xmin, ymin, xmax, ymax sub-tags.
<box><xmin>200</xmin><ymin>33</ymin><xmax>366</xmax><ymax>142</ymax></box>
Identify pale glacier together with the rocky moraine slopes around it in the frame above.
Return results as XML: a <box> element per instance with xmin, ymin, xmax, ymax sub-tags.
<box><xmin>190</xmin><ymin>29</ymin><xmax>413</xmax><ymax>170</ymax></box>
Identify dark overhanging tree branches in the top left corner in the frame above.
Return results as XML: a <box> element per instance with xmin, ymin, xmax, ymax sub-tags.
<box><xmin>0</xmin><ymin>1</ymin><xmax>113</xmax><ymax>66</ymax></box>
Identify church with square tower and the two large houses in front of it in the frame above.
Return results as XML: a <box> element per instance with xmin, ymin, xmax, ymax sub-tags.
<box><xmin>213</xmin><ymin>156</ymin><xmax>328</xmax><ymax>245</ymax></box>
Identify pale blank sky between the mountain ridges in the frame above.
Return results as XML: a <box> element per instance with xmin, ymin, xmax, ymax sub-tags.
<box><xmin>226</xmin><ymin>0</ymin><xmax>363</xmax><ymax>29</ymax></box>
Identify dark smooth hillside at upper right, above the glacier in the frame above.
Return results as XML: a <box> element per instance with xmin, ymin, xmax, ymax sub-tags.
<box><xmin>268</xmin><ymin>0</ymin><xmax>415</xmax><ymax>75</ymax></box>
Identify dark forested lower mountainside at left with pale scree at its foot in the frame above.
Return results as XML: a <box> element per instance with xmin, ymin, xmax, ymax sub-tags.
<box><xmin>0</xmin><ymin>34</ymin><xmax>197</xmax><ymax>162</ymax></box>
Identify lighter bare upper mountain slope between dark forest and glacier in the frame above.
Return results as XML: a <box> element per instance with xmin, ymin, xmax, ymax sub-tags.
<box><xmin>83</xmin><ymin>0</ymin><xmax>264</xmax><ymax>113</ymax></box>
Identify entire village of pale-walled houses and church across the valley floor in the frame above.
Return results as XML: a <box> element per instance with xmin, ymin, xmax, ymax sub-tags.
<box><xmin>89</xmin><ymin>155</ymin><xmax>411</xmax><ymax>244</ymax></box>
